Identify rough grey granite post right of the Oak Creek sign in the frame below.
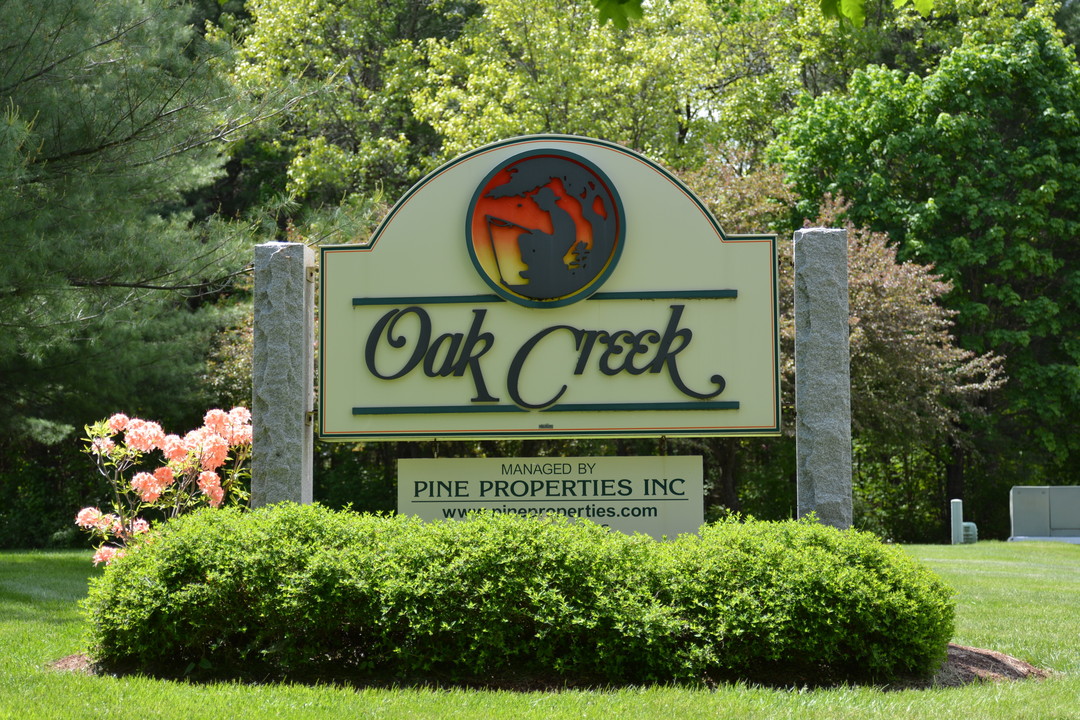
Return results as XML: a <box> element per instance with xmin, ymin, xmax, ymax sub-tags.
<box><xmin>795</xmin><ymin>228</ymin><xmax>851</xmax><ymax>529</ymax></box>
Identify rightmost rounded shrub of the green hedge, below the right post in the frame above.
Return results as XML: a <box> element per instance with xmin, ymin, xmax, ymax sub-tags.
<box><xmin>659</xmin><ymin>520</ymin><xmax>954</xmax><ymax>681</ymax></box>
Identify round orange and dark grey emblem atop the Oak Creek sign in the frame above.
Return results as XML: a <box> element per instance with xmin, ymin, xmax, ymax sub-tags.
<box><xmin>467</xmin><ymin>150</ymin><xmax>625</xmax><ymax>308</ymax></box>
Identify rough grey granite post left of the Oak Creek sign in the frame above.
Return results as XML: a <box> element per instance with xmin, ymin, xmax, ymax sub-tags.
<box><xmin>252</xmin><ymin>243</ymin><xmax>315</xmax><ymax>507</ymax></box>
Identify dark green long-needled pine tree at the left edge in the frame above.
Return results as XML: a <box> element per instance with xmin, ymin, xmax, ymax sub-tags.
<box><xmin>0</xmin><ymin>0</ymin><xmax>274</xmax><ymax>439</ymax></box>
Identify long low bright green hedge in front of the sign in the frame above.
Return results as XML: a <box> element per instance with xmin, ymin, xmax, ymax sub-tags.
<box><xmin>84</xmin><ymin>505</ymin><xmax>954</xmax><ymax>682</ymax></box>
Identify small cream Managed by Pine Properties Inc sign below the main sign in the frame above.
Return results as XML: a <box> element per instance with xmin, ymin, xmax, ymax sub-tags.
<box><xmin>397</xmin><ymin>456</ymin><xmax>704</xmax><ymax>540</ymax></box>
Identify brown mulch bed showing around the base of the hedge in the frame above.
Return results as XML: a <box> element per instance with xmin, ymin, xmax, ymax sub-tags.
<box><xmin>49</xmin><ymin>643</ymin><xmax>1051</xmax><ymax>691</ymax></box>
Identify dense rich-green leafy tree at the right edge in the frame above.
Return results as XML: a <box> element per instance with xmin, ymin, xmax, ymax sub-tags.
<box><xmin>777</xmin><ymin>16</ymin><xmax>1080</xmax><ymax>522</ymax></box>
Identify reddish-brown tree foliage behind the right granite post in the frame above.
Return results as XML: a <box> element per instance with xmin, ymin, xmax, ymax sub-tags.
<box><xmin>686</xmin><ymin>161</ymin><xmax>1004</xmax><ymax>447</ymax></box>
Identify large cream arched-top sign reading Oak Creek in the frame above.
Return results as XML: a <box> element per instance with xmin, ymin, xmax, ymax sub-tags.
<box><xmin>319</xmin><ymin>136</ymin><xmax>780</xmax><ymax>440</ymax></box>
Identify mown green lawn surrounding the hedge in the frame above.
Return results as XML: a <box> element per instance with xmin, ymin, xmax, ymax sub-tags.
<box><xmin>0</xmin><ymin>542</ymin><xmax>1080</xmax><ymax>720</ymax></box>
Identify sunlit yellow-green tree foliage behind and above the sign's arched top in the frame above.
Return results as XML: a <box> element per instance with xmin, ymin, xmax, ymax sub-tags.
<box><xmin>218</xmin><ymin>0</ymin><xmax>1036</xmax><ymax>206</ymax></box>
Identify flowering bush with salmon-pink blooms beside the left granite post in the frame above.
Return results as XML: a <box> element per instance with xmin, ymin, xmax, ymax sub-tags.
<box><xmin>75</xmin><ymin>407</ymin><xmax>252</xmax><ymax>565</ymax></box>
